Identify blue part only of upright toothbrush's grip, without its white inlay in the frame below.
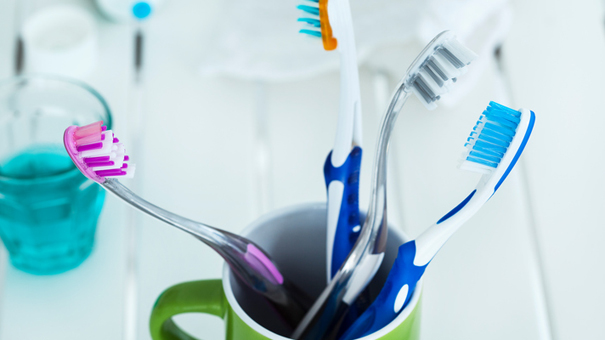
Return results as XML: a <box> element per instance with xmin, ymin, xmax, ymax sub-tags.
<box><xmin>324</xmin><ymin>146</ymin><xmax>362</xmax><ymax>277</ymax></box>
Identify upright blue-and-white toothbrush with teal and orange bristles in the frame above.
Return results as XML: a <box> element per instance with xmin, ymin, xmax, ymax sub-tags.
<box><xmin>297</xmin><ymin>0</ymin><xmax>362</xmax><ymax>283</ymax></box>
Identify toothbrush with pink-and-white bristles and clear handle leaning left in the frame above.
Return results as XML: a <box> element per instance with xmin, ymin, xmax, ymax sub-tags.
<box><xmin>63</xmin><ymin>122</ymin><xmax>312</xmax><ymax>329</ymax></box>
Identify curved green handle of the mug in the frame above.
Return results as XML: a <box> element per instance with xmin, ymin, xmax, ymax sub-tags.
<box><xmin>149</xmin><ymin>279</ymin><xmax>227</xmax><ymax>340</ymax></box>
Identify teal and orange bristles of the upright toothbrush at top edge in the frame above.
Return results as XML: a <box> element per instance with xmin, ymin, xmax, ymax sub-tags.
<box><xmin>296</xmin><ymin>0</ymin><xmax>338</xmax><ymax>51</ymax></box>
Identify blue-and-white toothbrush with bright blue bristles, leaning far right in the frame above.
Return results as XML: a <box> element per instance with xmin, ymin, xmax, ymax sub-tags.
<box><xmin>340</xmin><ymin>102</ymin><xmax>535</xmax><ymax>340</ymax></box>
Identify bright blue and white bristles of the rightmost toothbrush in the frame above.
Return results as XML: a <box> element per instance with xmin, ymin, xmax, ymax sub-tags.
<box><xmin>460</xmin><ymin>102</ymin><xmax>521</xmax><ymax>173</ymax></box>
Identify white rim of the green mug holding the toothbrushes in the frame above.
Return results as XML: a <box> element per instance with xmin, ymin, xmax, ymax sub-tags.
<box><xmin>221</xmin><ymin>202</ymin><xmax>424</xmax><ymax>340</ymax></box>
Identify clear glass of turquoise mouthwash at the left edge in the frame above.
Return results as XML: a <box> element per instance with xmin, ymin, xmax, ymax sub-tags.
<box><xmin>0</xmin><ymin>76</ymin><xmax>111</xmax><ymax>275</ymax></box>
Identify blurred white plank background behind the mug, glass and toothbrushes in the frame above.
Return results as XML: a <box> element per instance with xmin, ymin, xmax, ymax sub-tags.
<box><xmin>0</xmin><ymin>0</ymin><xmax>605</xmax><ymax>340</ymax></box>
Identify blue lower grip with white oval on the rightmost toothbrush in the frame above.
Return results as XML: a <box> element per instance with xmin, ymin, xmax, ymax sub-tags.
<box><xmin>339</xmin><ymin>241</ymin><xmax>428</xmax><ymax>340</ymax></box>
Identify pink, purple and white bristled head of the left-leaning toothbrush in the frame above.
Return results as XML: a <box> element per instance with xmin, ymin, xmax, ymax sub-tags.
<box><xmin>63</xmin><ymin>121</ymin><xmax>135</xmax><ymax>183</ymax></box>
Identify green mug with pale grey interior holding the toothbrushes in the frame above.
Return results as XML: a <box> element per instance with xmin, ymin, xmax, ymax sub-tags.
<box><xmin>149</xmin><ymin>203</ymin><xmax>422</xmax><ymax>340</ymax></box>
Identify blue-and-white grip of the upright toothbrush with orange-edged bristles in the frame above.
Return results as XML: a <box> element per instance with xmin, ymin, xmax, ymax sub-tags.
<box><xmin>324</xmin><ymin>146</ymin><xmax>362</xmax><ymax>282</ymax></box>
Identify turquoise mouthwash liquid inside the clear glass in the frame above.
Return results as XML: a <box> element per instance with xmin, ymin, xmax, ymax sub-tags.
<box><xmin>0</xmin><ymin>145</ymin><xmax>105</xmax><ymax>274</ymax></box>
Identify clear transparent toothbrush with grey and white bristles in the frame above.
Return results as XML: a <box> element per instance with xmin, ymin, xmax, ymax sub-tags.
<box><xmin>293</xmin><ymin>31</ymin><xmax>476</xmax><ymax>339</ymax></box>
